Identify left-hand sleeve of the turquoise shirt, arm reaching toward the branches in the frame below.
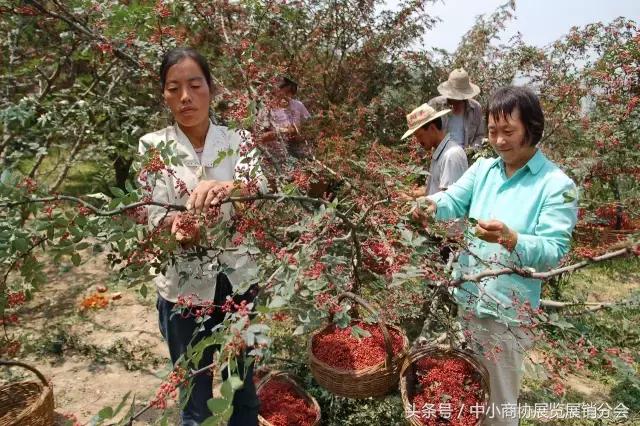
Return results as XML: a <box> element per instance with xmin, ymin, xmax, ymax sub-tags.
<box><xmin>427</xmin><ymin>161</ymin><xmax>480</xmax><ymax>220</ymax></box>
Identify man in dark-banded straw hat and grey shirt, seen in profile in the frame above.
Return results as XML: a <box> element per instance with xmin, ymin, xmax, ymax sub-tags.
<box><xmin>401</xmin><ymin>104</ymin><xmax>469</xmax><ymax>197</ymax></box>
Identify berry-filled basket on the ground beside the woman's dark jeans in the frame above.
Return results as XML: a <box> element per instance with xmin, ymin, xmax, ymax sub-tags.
<box><xmin>257</xmin><ymin>371</ymin><xmax>321</xmax><ymax>426</ymax></box>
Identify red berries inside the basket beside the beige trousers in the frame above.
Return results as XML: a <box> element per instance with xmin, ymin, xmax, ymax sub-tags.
<box><xmin>411</xmin><ymin>357</ymin><xmax>484</xmax><ymax>426</ymax></box>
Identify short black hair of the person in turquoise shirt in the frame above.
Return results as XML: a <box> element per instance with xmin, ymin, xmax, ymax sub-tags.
<box><xmin>487</xmin><ymin>86</ymin><xmax>544</xmax><ymax>146</ymax></box>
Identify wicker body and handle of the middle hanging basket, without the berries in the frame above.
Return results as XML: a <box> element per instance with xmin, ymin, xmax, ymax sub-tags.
<box><xmin>308</xmin><ymin>292</ymin><xmax>409</xmax><ymax>398</ymax></box>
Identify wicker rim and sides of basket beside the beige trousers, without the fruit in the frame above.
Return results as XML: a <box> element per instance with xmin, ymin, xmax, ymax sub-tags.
<box><xmin>400</xmin><ymin>346</ymin><xmax>491</xmax><ymax>426</ymax></box>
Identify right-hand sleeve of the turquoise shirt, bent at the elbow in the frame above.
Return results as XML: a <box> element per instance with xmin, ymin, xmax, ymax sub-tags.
<box><xmin>515</xmin><ymin>179</ymin><xmax>578</xmax><ymax>271</ymax></box>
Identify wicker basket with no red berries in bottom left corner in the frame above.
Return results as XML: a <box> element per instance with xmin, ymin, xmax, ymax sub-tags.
<box><xmin>0</xmin><ymin>360</ymin><xmax>53</xmax><ymax>426</ymax></box>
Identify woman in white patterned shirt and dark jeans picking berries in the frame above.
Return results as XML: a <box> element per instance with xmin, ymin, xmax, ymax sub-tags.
<box><xmin>140</xmin><ymin>48</ymin><xmax>258</xmax><ymax>426</ymax></box>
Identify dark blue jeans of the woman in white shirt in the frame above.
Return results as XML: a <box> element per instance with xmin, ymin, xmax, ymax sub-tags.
<box><xmin>156</xmin><ymin>274</ymin><xmax>259</xmax><ymax>426</ymax></box>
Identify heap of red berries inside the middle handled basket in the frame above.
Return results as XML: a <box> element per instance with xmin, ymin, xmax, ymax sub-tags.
<box><xmin>312</xmin><ymin>321</ymin><xmax>403</xmax><ymax>370</ymax></box>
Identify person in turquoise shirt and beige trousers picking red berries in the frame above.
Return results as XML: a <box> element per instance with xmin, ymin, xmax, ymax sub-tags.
<box><xmin>414</xmin><ymin>86</ymin><xmax>578</xmax><ymax>426</ymax></box>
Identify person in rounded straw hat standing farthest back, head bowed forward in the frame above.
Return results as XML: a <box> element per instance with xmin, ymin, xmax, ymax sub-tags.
<box><xmin>429</xmin><ymin>68</ymin><xmax>484</xmax><ymax>148</ymax></box>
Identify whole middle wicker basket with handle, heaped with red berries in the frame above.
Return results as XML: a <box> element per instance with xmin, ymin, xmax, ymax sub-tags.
<box><xmin>308</xmin><ymin>292</ymin><xmax>409</xmax><ymax>398</ymax></box>
